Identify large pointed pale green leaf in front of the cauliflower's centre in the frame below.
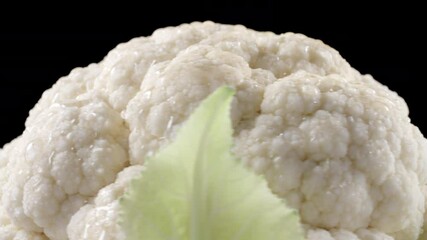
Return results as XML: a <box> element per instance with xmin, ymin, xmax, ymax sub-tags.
<box><xmin>121</xmin><ymin>87</ymin><xmax>303</xmax><ymax>240</ymax></box>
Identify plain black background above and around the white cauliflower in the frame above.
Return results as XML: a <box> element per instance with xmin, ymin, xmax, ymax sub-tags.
<box><xmin>0</xmin><ymin>4</ymin><xmax>427</xmax><ymax>147</ymax></box>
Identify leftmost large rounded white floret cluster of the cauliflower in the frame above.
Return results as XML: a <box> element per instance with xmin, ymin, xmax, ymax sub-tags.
<box><xmin>2</xmin><ymin>86</ymin><xmax>128</xmax><ymax>239</ymax></box>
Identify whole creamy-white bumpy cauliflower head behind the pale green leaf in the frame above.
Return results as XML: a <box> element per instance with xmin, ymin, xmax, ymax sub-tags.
<box><xmin>0</xmin><ymin>22</ymin><xmax>427</xmax><ymax>240</ymax></box>
